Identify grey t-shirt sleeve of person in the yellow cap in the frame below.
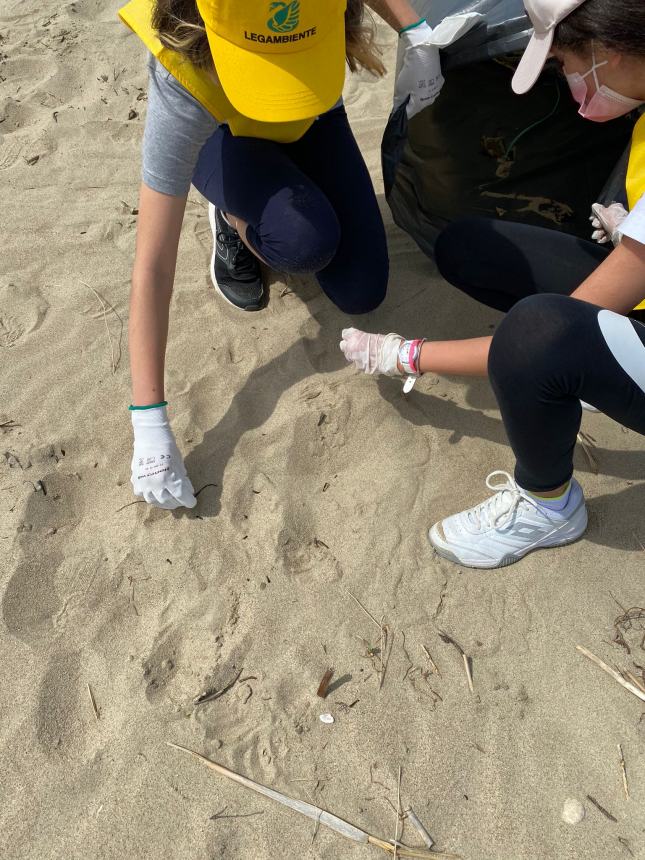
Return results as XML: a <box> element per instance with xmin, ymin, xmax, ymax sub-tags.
<box><xmin>143</xmin><ymin>54</ymin><xmax>343</xmax><ymax>197</ymax></box>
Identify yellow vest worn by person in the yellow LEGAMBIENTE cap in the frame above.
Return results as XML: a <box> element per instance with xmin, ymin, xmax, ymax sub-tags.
<box><xmin>119</xmin><ymin>0</ymin><xmax>316</xmax><ymax>143</ymax></box>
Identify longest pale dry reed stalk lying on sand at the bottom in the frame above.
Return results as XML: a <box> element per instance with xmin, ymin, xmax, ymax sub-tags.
<box><xmin>168</xmin><ymin>741</ymin><xmax>461</xmax><ymax>860</ymax></box>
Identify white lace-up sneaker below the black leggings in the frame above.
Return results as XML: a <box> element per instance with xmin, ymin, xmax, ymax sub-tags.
<box><xmin>428</xmin><ymin>472</ymin><xmax>587</xmax><ymax>568</ymax></box>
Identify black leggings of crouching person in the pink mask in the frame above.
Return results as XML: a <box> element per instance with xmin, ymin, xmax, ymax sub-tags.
<box><xmin>437</xmin><ymin>219</ymin><xmax>645</xmax><ymax>492</ymax></box>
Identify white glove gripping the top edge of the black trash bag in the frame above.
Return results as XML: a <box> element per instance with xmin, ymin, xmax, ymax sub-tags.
<box><xmin>393</xmin><ymin>12</ymin><xmax>482</xmax><ymax>119</ymax></box>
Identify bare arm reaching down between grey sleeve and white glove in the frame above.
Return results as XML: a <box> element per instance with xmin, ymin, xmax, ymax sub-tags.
<box><xmin>129</xmin><ymin>184</ymin><xmax>186</xmax><ymax>406</ymax></box>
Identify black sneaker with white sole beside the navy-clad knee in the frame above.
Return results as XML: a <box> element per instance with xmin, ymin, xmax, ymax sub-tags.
<box><xmin>208</xmin><ymin>203</ymin><xmax>264</xmax><ymax>311</ymax></box>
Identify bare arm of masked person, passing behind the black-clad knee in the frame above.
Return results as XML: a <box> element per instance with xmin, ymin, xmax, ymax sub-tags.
<box><xmin>416</xmin><ymin>236</ymin><xmax>645</xmax><ymax>376</ymax></box>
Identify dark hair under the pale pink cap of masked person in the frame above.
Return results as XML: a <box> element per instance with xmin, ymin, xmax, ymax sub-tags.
<box><xmin>553</xmin><ymin>0</ymin><xmax>645</xmax><ymax>57</ymax></box>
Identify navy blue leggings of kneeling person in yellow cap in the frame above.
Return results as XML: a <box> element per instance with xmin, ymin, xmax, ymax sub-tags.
<box><xmin>193</xmin><ymin>107</ymin><xmax>389</xmax><ymax>314</ymax></box>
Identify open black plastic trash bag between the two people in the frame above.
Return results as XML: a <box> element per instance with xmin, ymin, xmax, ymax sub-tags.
<box><xmin>382</xmin><ymin>0</ymin><xmax>635</xmax><ymax>256</ymax></box>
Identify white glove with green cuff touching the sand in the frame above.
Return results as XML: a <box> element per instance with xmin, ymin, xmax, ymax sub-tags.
<box><xmin>131</xmin><ymin>406</ymin><xmax>197</xmax><ymax>510</ymax></box>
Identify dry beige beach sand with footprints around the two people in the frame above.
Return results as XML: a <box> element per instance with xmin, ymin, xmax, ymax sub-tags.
<box><xmin>0</xmin><ymin>0</ymin><xmax>645</xmax><ymax>860</ymax></box>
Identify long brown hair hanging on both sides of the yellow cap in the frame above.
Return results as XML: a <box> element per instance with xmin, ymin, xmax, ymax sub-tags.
<box><xmin>152</xmin><ymin>0</ymin><xmax>385</xmax><ymax>76</ymax></box>
